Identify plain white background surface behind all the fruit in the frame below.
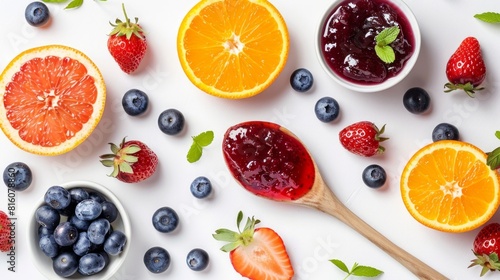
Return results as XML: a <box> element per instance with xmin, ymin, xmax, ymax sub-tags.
<box><xmin>0</xmin><ymin>0</ymin><xmax>500</xmax><ymax>280</ymax></box>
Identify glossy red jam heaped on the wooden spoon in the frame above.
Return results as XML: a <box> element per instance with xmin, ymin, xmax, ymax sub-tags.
<box><xmin>222</xmin><ymin>121</ymin><xmax>315</xmax><ymax>201</ymax></box>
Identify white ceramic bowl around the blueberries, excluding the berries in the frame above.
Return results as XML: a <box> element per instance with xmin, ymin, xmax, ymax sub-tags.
<box><xmin>28</xmin><ymin>181</ymin><xmax>132</xmax><ymax>280</ymax></box>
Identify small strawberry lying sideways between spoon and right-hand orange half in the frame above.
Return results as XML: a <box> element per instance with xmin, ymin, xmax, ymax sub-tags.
<box><xmin>339</xmin><ymin>121</ymin><xmax>388</xmax><ymax>157</ymax></box>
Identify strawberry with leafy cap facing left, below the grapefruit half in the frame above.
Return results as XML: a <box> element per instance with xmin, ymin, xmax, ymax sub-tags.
<box><xmin>100</xmin><ymin>138</ymin><xmax>158</xmax><ymax>183</ymax></box>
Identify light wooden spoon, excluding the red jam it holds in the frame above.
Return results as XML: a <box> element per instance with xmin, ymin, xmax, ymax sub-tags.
<box><xmin>222</xmin><ymin>121</ymin><xmax>448</xmax><ymax>280</ymax></box>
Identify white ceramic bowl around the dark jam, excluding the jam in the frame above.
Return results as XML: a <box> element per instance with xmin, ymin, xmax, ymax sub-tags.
<box><xmin>316</xmin><ymin>0</ymin><xmax>421</xmax><ymax>92</ymax></box>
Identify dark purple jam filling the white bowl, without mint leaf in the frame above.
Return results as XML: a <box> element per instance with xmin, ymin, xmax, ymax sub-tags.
<box><xmin>321</xmin><ymin>0</ymin><xmax>415</xmax><ymax>85</ymax></box>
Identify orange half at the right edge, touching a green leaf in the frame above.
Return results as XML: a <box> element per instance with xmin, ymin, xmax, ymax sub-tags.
<box><xmin>401</xmin><ymin>140</ymin><xmax>500</xmax><ymax>232</ymax></box>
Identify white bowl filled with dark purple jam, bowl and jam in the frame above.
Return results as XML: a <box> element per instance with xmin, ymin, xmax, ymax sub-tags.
<box><xmin>316</xmin><ymin>0</ymin><xmax>421</xmax><ymax>92</ymax></box>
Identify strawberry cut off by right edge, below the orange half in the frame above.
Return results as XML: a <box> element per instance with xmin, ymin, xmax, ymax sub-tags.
<box><xmin>469</xmin><ymin>223</ymin><xmax>500</xmax><ymax>276</ymax></box>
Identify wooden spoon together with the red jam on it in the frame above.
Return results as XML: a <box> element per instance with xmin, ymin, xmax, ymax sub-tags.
<box><xmin>222</xmin><ymin>121</ymin><xmax>448</xmax><ymax>280</ymax></box>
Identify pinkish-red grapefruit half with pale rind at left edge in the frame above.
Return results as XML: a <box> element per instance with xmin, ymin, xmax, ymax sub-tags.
<box><xmin>0</xmin><ymin>45</ymin><xmax>106</xmax><ymax>155</ymax></box>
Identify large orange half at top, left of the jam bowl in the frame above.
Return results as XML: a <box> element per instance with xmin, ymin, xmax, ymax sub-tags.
<box><xmin>177</xmin><ymin>0</ymin><xmax>289</xmax><ymax>99</ymax></box>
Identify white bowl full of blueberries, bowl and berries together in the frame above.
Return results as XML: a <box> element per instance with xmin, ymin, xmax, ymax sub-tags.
<box><xmin>28</xmin><ymin>181</ymin><xmax>131</xmax><ymax>279</ymax></box>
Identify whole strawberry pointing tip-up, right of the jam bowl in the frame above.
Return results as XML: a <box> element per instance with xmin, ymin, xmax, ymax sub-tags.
<box><xmin>444</xmin><ymin>37</ymin><xmax>486</xmax><ymax>97</ymax></box>
